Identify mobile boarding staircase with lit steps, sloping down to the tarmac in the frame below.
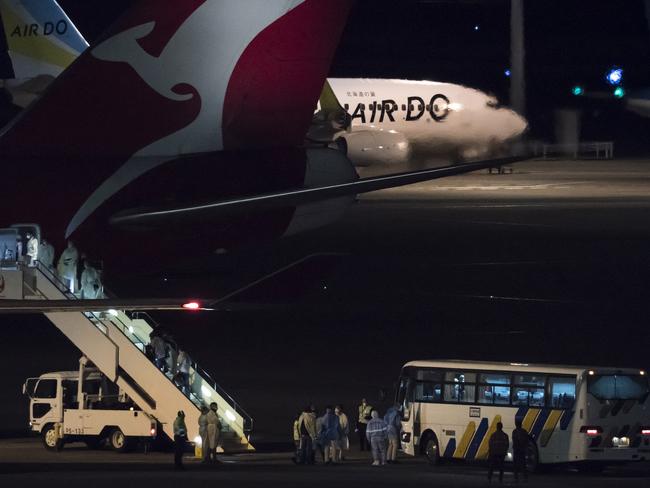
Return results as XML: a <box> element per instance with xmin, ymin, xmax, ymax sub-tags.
<box><xmin>2</xmin><ymin>263</ymin><xmax>254</xmax><ymax>453</ymax></box>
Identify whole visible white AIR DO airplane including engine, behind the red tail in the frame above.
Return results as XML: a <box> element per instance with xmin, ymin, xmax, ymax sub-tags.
<box><xmin>309</xmin><ymin>78</ymin><xmax>528</xmax><ymax>167</ymax></box>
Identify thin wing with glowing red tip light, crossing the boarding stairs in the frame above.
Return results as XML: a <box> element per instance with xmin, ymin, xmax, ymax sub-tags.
<box><xmin>0</xmin><ymin>298</ymin><xmax>214</xmax><ymax>314</ymax></box>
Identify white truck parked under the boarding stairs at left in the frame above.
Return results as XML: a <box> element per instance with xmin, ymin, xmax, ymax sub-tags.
<box><xmin>23</xmin><ymin>357</ymin><xmax>158</xmax><ymax>452</ymax></box>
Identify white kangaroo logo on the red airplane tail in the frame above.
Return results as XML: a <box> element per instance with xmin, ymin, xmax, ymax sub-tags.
<box><xmin>66</xmin><ymin>0</ymin><xmax>306</xmax><ymax>236</ymax></box>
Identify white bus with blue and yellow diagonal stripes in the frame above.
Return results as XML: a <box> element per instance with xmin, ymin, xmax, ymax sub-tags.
<box><xmin>397</xmin><ymin>360</ymin><xmax>650</xmax><ymax>470</ymax></box>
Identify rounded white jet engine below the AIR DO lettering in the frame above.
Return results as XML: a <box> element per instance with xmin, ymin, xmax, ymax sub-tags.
<box><xmin>335</xmin><ymin>130</ymin><xmax>410</xmax><ymax>167</ymax></box>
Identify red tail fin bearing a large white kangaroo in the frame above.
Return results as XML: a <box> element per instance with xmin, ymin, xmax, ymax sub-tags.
<box><xmin>0</xmin><ymin>0</ymin><xmax>352</xmax><ymax>156</ymax></box>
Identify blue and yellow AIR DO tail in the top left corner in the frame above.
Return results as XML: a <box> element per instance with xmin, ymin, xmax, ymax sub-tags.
<box><xmin>0</xmin><ymin>0</ymin><xmax>88</xmax><ymax>80</ymax></box>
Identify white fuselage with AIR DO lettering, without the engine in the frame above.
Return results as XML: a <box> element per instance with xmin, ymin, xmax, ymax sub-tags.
<box><xmin>328</xmin><ymin>78</ymin><xmax>527</xmax><ymax>161</ymax></box>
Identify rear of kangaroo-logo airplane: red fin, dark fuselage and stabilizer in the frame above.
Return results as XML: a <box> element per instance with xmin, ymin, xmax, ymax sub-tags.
<box><xmin>0</xmin><ymin>0</ymin><xmax>520</xmax><ymax>269</ymax></box>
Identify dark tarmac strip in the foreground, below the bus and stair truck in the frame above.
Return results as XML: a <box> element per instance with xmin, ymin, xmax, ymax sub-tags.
<box><xmin>0</xmin><ymin>439</ymin><xmax>650</xmax><ymax>488</ymax></box>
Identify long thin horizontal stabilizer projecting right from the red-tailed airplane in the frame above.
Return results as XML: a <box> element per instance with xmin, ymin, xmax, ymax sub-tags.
<box><xmin>111</xmin><ymin>156</ymin><xmax>528</xmax><ymax>226</ymax></box>
